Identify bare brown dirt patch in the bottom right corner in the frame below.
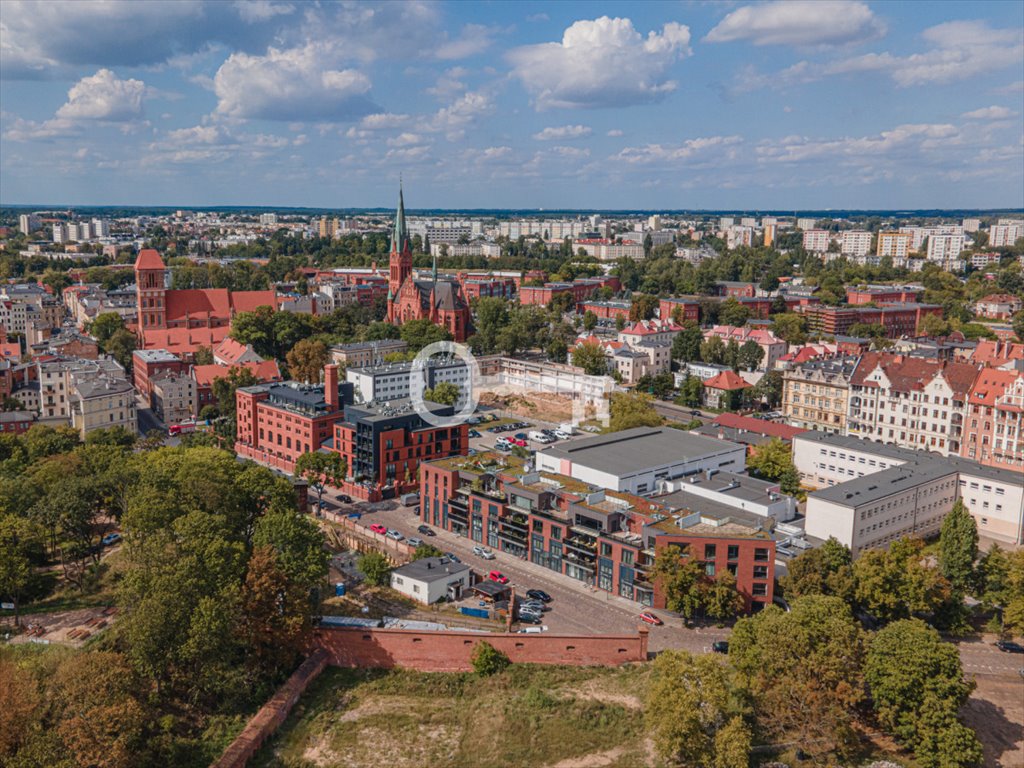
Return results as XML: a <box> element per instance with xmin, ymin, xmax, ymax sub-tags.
<box><xmin>962</xmin><ymin>675</ymin><xmax>1024</xmax><ymax>768</ymax></box>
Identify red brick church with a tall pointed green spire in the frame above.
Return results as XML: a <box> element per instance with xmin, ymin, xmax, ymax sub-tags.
<box><xmin>387</xmin><ymin>187</ymin><xmax>472</xmax><ymax>341</ymax></box>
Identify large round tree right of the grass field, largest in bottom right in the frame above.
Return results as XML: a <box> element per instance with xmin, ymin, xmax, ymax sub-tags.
<box><xmin>729</xmin><ymin>596</ymin><xmax>864</xmax><ymax>758</ymax></box>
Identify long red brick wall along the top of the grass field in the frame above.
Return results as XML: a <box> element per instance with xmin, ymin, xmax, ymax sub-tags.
<box><xmin>313</xmin><ymin>627</ymin><xmax>647</xmax><ymax>672</ymax></box>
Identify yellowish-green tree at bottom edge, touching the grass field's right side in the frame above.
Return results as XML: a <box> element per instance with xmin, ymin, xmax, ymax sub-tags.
<box><xmin>644</xmin><ymin>650</ymin><xmax>751</xmax><ymax>768</ymax></box>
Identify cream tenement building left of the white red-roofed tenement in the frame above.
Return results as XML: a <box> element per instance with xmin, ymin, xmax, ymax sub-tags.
<box><xmin>782</xmin><ymin>357</ymin><xmax>858</xmax><ymax>434</ymax></box>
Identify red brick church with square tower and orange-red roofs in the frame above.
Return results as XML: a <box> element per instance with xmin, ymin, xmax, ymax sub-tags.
<box><xmin>135</xmin><ymin>248</ymin><xmax>278</xmax><ymax>356</ymax></box>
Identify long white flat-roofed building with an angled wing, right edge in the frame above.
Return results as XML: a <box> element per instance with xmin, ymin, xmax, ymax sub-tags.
<box><xmin>793</xmin><ymin>432</ymin><xmax>1024</xmax><ymax>554</ymax></box>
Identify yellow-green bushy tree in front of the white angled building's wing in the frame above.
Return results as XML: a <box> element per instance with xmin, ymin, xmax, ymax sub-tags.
<box><xmin>853</xmin><ymin>539</ymin><xmax>949</xmax><ymax>622</ymax></box>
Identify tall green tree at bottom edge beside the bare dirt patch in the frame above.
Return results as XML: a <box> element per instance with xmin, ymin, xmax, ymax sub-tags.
<box><xmin>864</xmin><ymin>618</ymin><xmax>982</xmax><ymax>768</ymax></box>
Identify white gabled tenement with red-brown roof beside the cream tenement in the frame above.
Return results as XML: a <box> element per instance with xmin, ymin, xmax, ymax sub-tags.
<box><xmin>848</xmin><ymin>352</ymin><xmax>978</xmax><ymax>456</ymax></box>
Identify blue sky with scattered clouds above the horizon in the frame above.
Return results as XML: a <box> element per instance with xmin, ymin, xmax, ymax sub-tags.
<box><xmin>0</xmin><ymin>0</ymin><xmax>1024</xmax><ymax>210</ymax></box>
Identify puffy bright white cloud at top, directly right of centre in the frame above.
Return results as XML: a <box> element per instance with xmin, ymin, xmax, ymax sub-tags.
<box><xmin>507</xmin><ymin>16</ymin><xmax>691</xmax><ymax>110</ymax></box>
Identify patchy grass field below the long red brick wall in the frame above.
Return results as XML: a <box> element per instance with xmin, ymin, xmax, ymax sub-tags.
<box><xmin>253</xmin><ymin>665</ymin><xmax>652</xmax><ymax>768</ymax></box>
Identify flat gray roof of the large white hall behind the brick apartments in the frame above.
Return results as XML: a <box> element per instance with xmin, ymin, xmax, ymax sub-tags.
<box><xmin>541</xmin><ymin>427</ymin><xmax>743</xmax><ymax>475</ymax></box>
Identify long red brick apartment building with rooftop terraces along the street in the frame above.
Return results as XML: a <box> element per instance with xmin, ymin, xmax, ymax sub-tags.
<box><xmin>419</xmin><ymin>453</ymin><xmax>775</xmax><ymax>610</ymax></box>
